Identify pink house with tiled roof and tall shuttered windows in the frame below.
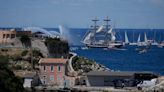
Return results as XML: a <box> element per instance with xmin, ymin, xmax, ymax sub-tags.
<box><xmin>39</xmin><ymin>58</ymin><xmax>67</xmax><ymax>86</ymax></box>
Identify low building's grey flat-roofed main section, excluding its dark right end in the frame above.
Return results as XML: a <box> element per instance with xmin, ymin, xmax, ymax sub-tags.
<box><xmin>86</xmin><ymin>71</ymin><xmax>134</xmax><ymax>86</ymax></box>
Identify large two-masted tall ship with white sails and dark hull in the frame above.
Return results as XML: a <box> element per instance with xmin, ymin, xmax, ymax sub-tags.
<box><xmin>82</xmin><ymin>17</ymin><xmax>123</xmax><ymax>48</ymax></box>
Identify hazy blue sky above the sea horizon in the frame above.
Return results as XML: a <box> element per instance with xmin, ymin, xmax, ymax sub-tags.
<box><xmin>0</xmin><ymin>0</ymin><xmax>164</xmax><ymax>28</ymax></box>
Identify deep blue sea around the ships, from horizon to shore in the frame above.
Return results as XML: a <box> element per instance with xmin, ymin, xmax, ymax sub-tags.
<box><xmin>2</xmin><ymin>28</ymin><xmax>164</xmax><ymax>75</ymax></box>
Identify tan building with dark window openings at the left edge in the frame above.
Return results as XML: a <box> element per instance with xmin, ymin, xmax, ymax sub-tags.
<box><xmin>0</xmin><ymin>29</ymin><xmax>16</xmax><ymax>44</ymax></box>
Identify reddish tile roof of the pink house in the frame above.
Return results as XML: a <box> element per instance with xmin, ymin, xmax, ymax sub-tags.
<box><xmin>39</xmin><ymin>58</ymin><xmax>68</xmax><ymax>64</ymax></box>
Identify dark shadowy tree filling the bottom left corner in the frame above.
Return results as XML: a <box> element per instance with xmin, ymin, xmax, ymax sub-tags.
<box><xmin>0</xmin><ymin>55</ymin><xmax>24</xmax><ymax>92</ymax></box>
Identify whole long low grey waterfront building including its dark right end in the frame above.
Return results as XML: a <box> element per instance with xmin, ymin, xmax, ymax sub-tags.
<box><xmin>86</xmin><ymin>71</ymin><xmax>158</xmax><ymax>87</ymax></box>
